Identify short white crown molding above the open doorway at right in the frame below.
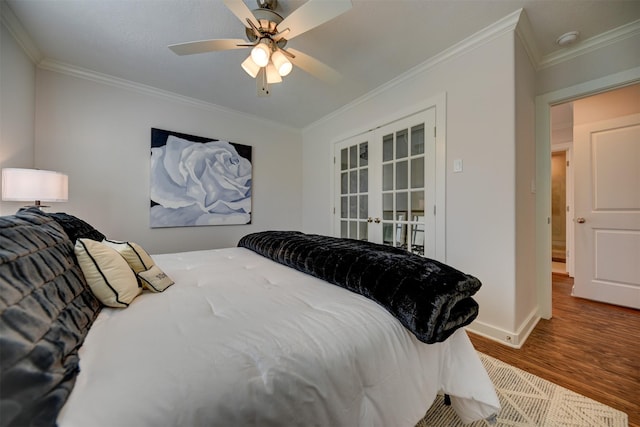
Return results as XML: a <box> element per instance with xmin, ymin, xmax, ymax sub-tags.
<box><xmin>536</xmin><ymin>19</ymin><xmax>640</xmax><ymax>70</ymax></box>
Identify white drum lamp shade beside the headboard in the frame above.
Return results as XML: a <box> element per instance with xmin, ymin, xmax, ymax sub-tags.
<box><xmin>2</xmin><ymin>168</ymin><xmax>69</xmax><ymax>202</ymax></box>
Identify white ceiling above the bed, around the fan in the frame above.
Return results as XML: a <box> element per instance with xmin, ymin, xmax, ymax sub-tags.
<box><xmin>3</xmin><ymin>0</ymin><xmax>640</xmax><ymax>128</ymax></box>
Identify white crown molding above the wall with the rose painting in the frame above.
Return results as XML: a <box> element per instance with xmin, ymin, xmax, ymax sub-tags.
<box><xmin>38</xmin><ymin>59</ymin><xmax>300</xmax><ymax>132</ymax></box>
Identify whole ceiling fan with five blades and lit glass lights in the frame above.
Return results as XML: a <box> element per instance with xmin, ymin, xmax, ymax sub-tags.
<box><xmin>169</xmin><ymin>0</ymin><xmax>351</xmax><ymax>96</ymax></box>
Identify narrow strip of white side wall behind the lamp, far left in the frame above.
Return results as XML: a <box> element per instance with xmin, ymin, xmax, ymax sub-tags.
<box><xmin>0</xmin><ymin>20</ymin><xmax>36</xmax><ymax>215</ymax></box>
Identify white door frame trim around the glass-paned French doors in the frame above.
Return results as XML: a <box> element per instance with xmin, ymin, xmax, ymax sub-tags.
<box><xmin>328</xmin><ymin>92</ymin><xmax>447</xmax><ymax>263</ymax></box>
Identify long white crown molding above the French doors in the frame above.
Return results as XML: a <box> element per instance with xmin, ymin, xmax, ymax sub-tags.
<box><xmin>303</xmin><ymin>9</ymin><xmax>524</xmax><ymax>131</ymax></box>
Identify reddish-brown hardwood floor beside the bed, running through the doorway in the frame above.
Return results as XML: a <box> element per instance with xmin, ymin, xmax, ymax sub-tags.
<box><xmin>469</xmin><ymin>274</ymin><xmax>640</xmax><ymax>427</ymax></box>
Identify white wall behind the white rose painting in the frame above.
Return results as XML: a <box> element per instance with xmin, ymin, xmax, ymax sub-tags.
<box><xmin>35</xmin><ymin>69</ymin><xmax>302</xmax><ymax>253</ymax></box>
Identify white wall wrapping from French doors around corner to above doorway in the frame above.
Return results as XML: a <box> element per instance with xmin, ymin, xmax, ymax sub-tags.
<box><xmin>303</xmin><ymin>10</ymin><xmax>640</xmax><ymax>346</ymax></box>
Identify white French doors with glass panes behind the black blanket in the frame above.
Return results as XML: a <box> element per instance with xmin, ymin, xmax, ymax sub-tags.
<box><xmin>334</xmin><ymin>108</ymin><xmax>436</xmax><ymax>258</ymax></box>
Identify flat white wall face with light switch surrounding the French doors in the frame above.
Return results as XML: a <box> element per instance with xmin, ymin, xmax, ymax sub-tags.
<box><xmin>302</xmin><ymin>27</ymin><xmax>516</xmax><ymax>342</ymax></box>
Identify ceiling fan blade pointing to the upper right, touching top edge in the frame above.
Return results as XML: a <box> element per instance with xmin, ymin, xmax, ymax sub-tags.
<box><xmin>278</xmin><ymin>0</ymin><xmax>351</xmax><ymax>40</ymax></box>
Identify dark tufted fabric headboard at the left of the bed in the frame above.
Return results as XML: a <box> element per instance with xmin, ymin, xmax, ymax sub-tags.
<box><xmin>0</xmin><ymin>209</ymin><xmax>101</xmax><ymax>426</ymax></box>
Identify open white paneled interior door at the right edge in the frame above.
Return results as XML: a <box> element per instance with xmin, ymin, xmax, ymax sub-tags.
<box><xmin>573</xmin><ymin>114</ymin><xmax>640</xmax><ymax>309</ymax></box>
